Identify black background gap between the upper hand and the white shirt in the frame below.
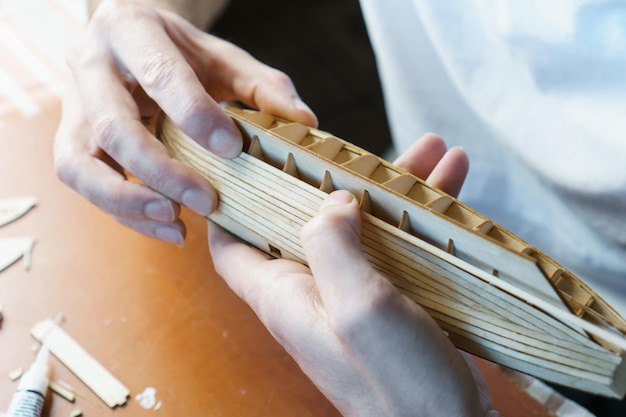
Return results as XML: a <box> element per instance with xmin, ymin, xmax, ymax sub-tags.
<box><xmin>211</xmin><ymin>0</ymin><xmax>390</xmax><ymax>156</ymax></box>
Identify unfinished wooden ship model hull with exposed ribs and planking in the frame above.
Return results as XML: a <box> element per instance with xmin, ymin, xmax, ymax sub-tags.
<box><xmin>157</xmin><ymin>108</ymin><xmax>626</xmax><ymax>398</ymax></box>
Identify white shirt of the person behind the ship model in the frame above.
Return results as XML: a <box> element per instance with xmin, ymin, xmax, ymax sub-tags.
<box><xmin>361</xmin><ymin>0</ymin><xmax>626</xmax><ymax>314</ymax></box>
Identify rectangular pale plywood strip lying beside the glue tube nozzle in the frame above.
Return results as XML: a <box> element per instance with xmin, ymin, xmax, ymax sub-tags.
<box><xmin>31</xmin><ymin>319</ymin><xmax>130</xmax><ymax>408</ymax></box>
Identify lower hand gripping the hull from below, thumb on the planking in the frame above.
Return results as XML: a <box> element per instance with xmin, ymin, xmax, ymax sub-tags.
<box><xmin>209</xmin><ymin>134</ymin><xmax>497</xmax><ymax>417</ymax></box>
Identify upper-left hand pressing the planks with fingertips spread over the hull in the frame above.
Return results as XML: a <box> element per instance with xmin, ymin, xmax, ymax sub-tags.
<box><xmin>54</xmin><ymin>1</ymin><xmax>317</xmax><ymax>243</ymax></box>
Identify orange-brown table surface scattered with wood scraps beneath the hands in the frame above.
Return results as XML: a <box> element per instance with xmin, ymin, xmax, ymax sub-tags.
<box><xmin>0</xmin><ymin>103</ymin><xmax>551</xmax><ymax>417</ymax></box>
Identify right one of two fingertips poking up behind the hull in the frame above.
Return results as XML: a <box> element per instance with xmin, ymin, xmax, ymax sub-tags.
<box><xmin>426</xmin><ymin>147</ymin><xmax>469</xmax><ymax>197</ymax></box>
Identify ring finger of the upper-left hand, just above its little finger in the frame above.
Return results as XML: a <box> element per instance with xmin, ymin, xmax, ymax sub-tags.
<box><xmin>54</xmin><ymin>90</ymin><xmax>180</xmax><ymax>228</ymax></box>
